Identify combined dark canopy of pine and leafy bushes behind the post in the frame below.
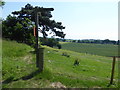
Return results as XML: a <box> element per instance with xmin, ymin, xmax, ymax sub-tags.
<box><xmin>2</xmin><ymin>4</ymin><xmax>65</xmax><ymax>45</ymax></box>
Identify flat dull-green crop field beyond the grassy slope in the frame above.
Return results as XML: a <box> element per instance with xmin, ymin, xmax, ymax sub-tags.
<box><xmin>61</xmin><ymin>42</ymin><xmax>118</xmax><ymax>56</ymax></box>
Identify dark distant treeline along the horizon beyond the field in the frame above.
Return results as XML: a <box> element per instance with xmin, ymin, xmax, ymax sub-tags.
<box><xmin>57</xmin><ymin>39</ymin><xmax>120</xmax><ymax>45</ymax></box>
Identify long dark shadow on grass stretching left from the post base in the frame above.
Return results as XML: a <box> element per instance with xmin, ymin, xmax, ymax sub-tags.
<box><xmin>2</xmin><ymin>70</ymin><xmax>41</xmax><ymax>84</ymax></box>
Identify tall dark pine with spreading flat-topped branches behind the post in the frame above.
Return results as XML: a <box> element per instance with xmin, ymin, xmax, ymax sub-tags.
<box><xmin>12</xmin><ymin>4</ymin><xmax>65</xmax><ymax>38</ymax></box>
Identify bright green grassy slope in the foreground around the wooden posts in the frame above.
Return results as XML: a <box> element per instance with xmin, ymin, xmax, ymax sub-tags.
<box><xmin>2</xmin><ymin>40</ymin><xmax>118</xmax><ymax>88</ymax></box>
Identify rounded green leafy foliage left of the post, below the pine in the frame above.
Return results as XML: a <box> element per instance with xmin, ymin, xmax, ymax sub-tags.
<box><xmin>2</xmin><ymin>15</ymin><xmax>35</xmax><ymax>46</ymax></box>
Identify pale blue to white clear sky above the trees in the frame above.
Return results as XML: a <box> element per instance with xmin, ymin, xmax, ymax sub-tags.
<box><xmin>2</xmin><ymin>0</ymin><xmax>118</xmax><ymax>40</ymax></box>
